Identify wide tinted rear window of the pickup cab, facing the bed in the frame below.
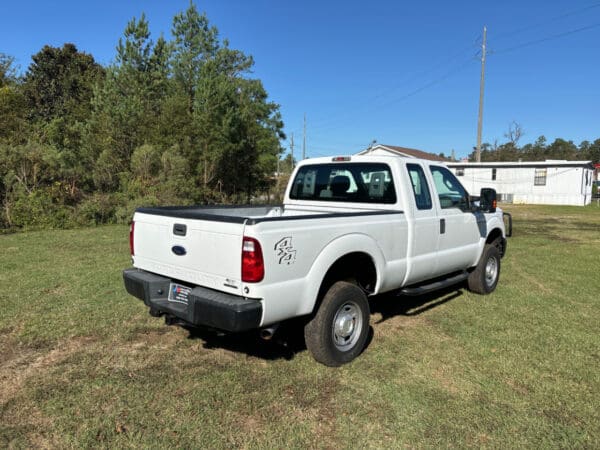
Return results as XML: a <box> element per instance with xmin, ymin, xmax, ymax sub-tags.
<box><xmin>290</xmin><ymin>163</ymin><xmax>396</xmax><ymax>204</ymax></box>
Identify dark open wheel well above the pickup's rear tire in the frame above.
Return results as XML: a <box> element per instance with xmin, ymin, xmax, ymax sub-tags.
<box><xmin>317</xmin><ymin>252</ymin><xmax>377</xmax><ymax>304</ymax></box>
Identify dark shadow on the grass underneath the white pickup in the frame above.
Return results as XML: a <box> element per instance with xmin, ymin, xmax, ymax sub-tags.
<box><xmin>187</xmin><ymin>285</ymin><xmax>463</xmax><ymax>361</ymax></box>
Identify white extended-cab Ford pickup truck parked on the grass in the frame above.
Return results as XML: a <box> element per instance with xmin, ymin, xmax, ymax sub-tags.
<box><xmin>123</xmin><ymin>156</ymin><xmax>506</xmax><ymax>366</ymax></box>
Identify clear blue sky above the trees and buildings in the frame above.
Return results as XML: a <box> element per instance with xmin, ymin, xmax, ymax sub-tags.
<box><xmin>0</xmin><ymin>0</ymin><xmax>600</xmax><ymax>160</ymax></box>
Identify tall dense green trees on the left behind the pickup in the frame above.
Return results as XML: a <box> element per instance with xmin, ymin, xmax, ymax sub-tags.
<box><xmin>0</xmin><ymin>4</ymin><xmax>285</xmax><ymax>229</ymax></box>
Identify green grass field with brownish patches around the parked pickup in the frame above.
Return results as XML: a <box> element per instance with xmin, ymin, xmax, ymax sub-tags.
<box><xmin>0</xmin><ymin>204</ymin><xmax>600</xmax><ymax>448</ymax></box>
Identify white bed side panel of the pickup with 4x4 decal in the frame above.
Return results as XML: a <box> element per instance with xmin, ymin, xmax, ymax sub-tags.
<box><xmin>244</xmin><ymin>211</ymin><xmax>408</xmax><ymax>325</ymax></box>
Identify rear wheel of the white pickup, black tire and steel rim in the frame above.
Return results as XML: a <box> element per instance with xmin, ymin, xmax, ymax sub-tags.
<box><xmin>304</xmin><ymin>281</ymin><xmax>370</xmax><ymax>367</ymax></box>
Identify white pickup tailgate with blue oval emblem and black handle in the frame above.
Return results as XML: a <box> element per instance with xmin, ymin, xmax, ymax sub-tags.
<box><xmin>133</xmin><ymin>212</ymin><xmax>244</xmax><ymax>295</ymax></box>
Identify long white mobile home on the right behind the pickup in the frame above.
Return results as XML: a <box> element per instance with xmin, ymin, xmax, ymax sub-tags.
<box><xmin>446</xmin><ymin>160</ymin><xmax>594</xmax><ymax>206</ymax></box>
